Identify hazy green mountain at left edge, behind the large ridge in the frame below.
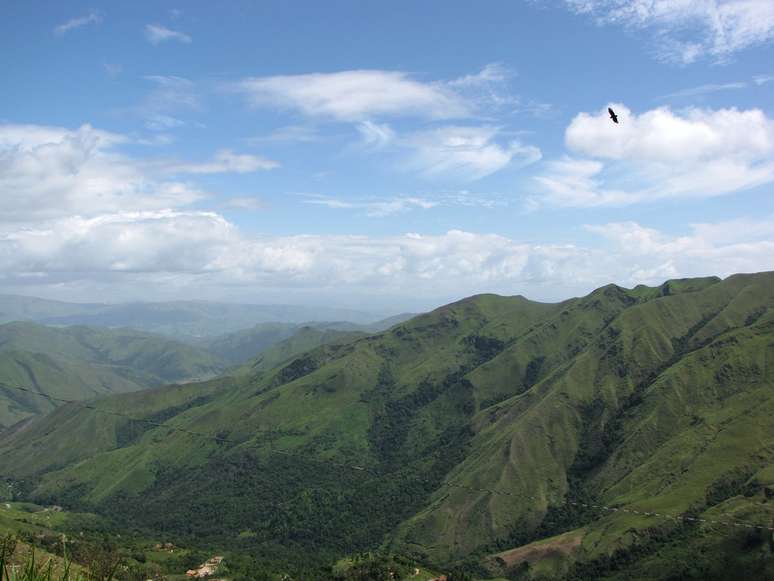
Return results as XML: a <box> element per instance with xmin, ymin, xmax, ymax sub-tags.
<box><xmin>0</xmin><ymin>323</ymin><xmax>226</xmax><ymax>428</ymax></box>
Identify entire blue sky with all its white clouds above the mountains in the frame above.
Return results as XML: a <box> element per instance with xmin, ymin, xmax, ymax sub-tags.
<box><xmin>0</xmin><ymin>0</ymin><xmax>774</xmax><ymax>311</ymax></box>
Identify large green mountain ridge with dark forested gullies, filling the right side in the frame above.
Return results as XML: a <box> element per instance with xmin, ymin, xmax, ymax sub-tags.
<box><xmin>0</xmin><ymin>273</ymin><xmax>774</xmax><ymax>579</ymax></box>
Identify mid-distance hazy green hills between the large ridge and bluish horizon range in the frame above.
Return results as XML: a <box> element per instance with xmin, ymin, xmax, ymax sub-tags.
<box><xmin>0</xmin><ymin>315</ymin><xmax>418</xmax><ymax>429</ymax></box>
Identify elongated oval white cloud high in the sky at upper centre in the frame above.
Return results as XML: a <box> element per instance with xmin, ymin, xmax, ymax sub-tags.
<box><xmin>237</xmin><ymin>70</ymin><xmax>469</xmax><ymax>122</ymax></box>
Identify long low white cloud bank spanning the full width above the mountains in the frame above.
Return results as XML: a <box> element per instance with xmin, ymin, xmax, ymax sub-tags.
<box><xmin>6</xmin><ymin>210</ymin><xmax>774</xmax><ymax>303</ymax></box>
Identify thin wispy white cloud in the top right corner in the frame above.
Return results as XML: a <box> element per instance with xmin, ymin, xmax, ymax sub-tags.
<box><xmin>565</xmin><ymin>0</ymin><xmax>774</xmax><ymax>63</ymax></box>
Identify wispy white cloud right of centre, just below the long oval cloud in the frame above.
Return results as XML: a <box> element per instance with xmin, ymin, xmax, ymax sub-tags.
<box><xmin>401</xmin><ymin>126</ymin><xmax>541</xmax><ymax>180</ymax></box>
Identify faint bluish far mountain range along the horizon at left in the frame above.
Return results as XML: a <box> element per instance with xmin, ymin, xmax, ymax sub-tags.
<box><xmin>0</xmin><ymin>295</ymin><xmax>386</xmax><ymax>338</ymax></box>
